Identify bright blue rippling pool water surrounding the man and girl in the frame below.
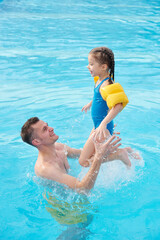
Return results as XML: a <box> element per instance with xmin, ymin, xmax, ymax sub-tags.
<box><xmin>0</xmin><ymin>0</ymin><xmax>160</xmax><ymax>240</ymax></box>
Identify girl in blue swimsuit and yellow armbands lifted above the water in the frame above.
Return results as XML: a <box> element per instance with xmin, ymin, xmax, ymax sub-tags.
<box><xmin>79</xmin><ymin>47</ymin><xmax>132</xmax><ymax>166</ymax></box>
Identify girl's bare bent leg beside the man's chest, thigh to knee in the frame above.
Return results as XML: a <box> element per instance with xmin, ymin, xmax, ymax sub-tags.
<box><xmin>79</xmin><ymin>129</ymin><xmax>95</xmax><ymax>167</ymax></box>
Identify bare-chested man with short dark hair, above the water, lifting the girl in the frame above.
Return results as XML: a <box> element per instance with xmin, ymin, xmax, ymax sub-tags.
<box><xmin>21</xmin><ymin>117</ymin><xmax>121</xmax><ymax>191</ymax></box>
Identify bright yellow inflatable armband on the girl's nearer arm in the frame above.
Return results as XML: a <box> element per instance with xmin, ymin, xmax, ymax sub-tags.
<box><xmin>100</xmin><ymin>83</ymin><xmax>129</xmax><ymax>109</ymax></box>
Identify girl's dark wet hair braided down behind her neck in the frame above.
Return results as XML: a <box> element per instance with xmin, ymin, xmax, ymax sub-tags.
<box><xmin>89</xmin><ymin>47</ymin><xmax>115</xmax><ymax>84</ymax></box>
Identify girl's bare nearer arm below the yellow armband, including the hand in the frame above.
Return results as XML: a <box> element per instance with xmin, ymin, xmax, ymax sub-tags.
<box><xmin>95</xmin><ymin>103</ymin><xmax>123</xmax><ymax>141</ymax></box>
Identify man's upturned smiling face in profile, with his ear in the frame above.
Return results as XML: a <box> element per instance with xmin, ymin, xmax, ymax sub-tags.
<box><xmin>32</xmin><ymin>120</ymin><xmax>59</xmax><ymax>145</ymax></box>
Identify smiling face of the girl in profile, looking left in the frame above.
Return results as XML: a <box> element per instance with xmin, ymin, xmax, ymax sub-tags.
<box><xmin>87</xmin><ymin>54</ymin><xmax>106</xmax><ymax>77</ymax></box>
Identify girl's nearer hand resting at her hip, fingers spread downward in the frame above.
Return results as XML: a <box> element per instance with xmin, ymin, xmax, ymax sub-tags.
<box><xmin>94</xmin><ymin>123</ymin><xmax>110</xmax><ymax>142</ymax></box>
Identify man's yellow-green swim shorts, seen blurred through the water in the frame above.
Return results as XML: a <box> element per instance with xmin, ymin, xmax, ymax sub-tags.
<box><xmin>43</xmin><ymin>189</ymin><xmax>95</xmax><ymax>226</ymax></box>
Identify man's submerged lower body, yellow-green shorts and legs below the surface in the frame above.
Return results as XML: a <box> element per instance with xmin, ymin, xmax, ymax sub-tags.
<box><xmin>43</xmin><ymin>191</ymin><xmax>96</xmax><ymax>240</ymax></box>
